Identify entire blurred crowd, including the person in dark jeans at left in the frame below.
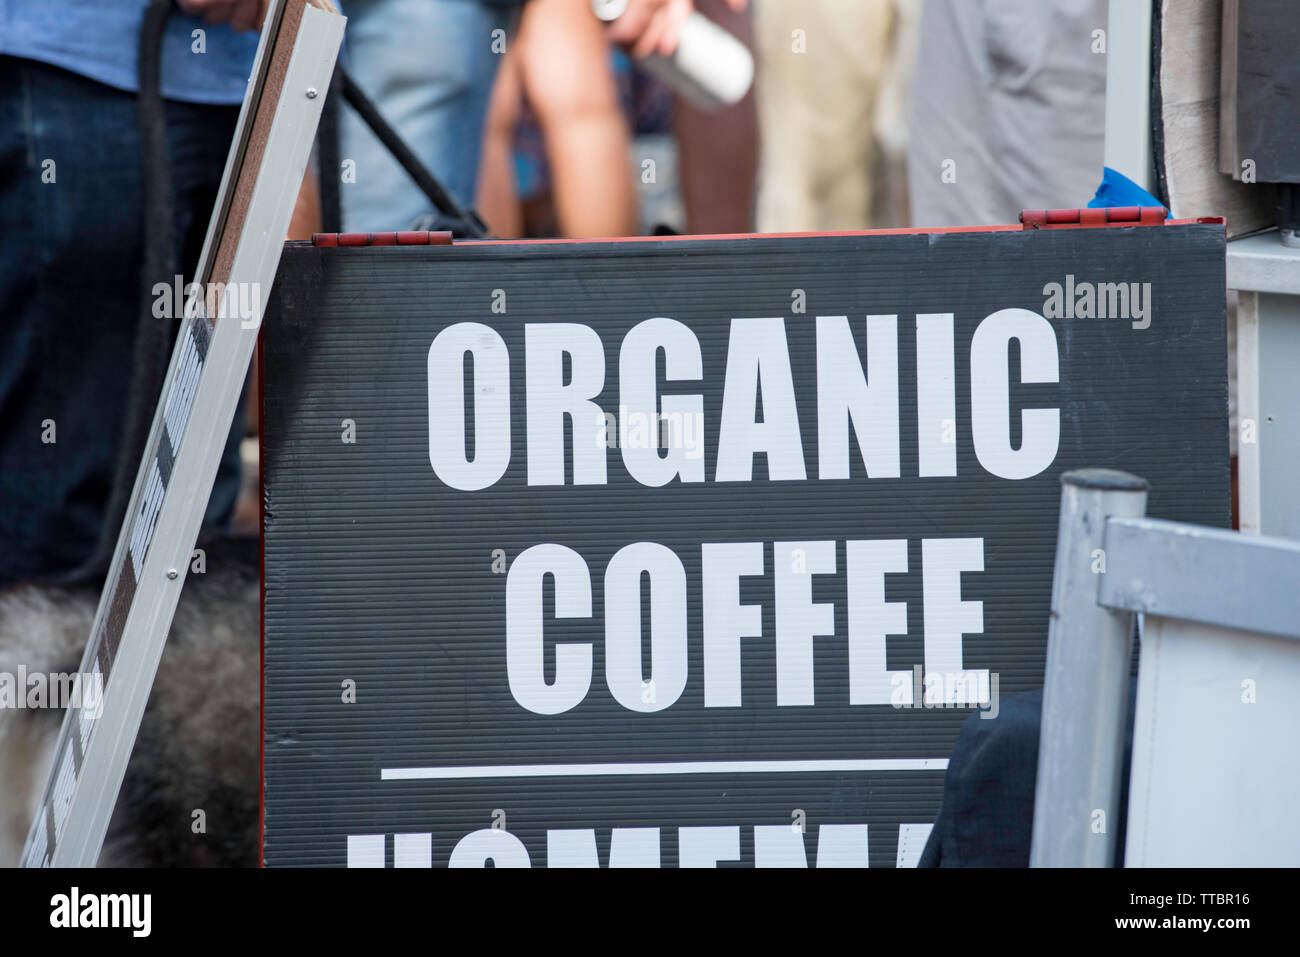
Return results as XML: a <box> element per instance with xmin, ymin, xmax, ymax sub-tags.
<box><xmin>0</xmin><ymin>0</ymin><xmax>1106</xmax><ymax>585</ymax></box>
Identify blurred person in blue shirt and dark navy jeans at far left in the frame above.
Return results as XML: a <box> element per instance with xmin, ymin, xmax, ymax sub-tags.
<box><xmin>0</xmin><ymin>0</ymin><xmax>267</xmax><ymax>585</ymax></box>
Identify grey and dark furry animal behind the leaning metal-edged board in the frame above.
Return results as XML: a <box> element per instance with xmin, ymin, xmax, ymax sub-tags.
<box><xmin>0</xmin><ymin>538</ymin><xmax>260</xmax><ymax>867</ymax></box>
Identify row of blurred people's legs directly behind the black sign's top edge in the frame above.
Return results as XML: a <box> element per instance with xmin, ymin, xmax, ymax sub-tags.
<box><xmin>339</xmin><ymin>0</ymin><xmax>1106</xmax><ymax>238</ymax></box>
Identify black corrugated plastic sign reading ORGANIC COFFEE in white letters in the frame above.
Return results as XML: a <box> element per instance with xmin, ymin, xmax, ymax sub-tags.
<box><xmin>263</xmin><ymin>225</ymin><xmax>1229</xmax><ymax>866</ymax></box>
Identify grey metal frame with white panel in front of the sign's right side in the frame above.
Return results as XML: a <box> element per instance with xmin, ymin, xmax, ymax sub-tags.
<box><xmin>1030</xmin><ymin>469</ymin><xmax>1300</xmax><ymax>866</ymax></box>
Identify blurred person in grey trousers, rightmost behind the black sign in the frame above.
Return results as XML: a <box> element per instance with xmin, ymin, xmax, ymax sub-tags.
<box><xmin>909</xmin><ymin>0</ymin><xmax>1106</xmax><ymax>228</ymax></box>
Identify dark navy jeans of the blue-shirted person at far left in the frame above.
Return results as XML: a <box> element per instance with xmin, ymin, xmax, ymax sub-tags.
<box><xmin>0</xmin><ymin>56</ymin><xmax>242</xmax><ymax>585</ymax></box>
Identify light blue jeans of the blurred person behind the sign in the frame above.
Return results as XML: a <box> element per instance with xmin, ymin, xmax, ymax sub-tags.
<box><xmin>339</xmin><ymin>0</ymin><xmax>511</xmax><ymax>233</ymax></box>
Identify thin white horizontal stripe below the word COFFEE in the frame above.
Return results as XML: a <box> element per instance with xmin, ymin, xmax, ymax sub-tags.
<box><xmin>380</xmin><ymin>758</ymin><xmax>948</xmax><ymax>781</ymax></box>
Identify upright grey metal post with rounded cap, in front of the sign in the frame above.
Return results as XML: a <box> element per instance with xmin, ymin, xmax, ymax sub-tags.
<box><xmin>1030</xmin><ymin>468</ymin><xmax>1148</xmax><ymax>867</ymax></box>
